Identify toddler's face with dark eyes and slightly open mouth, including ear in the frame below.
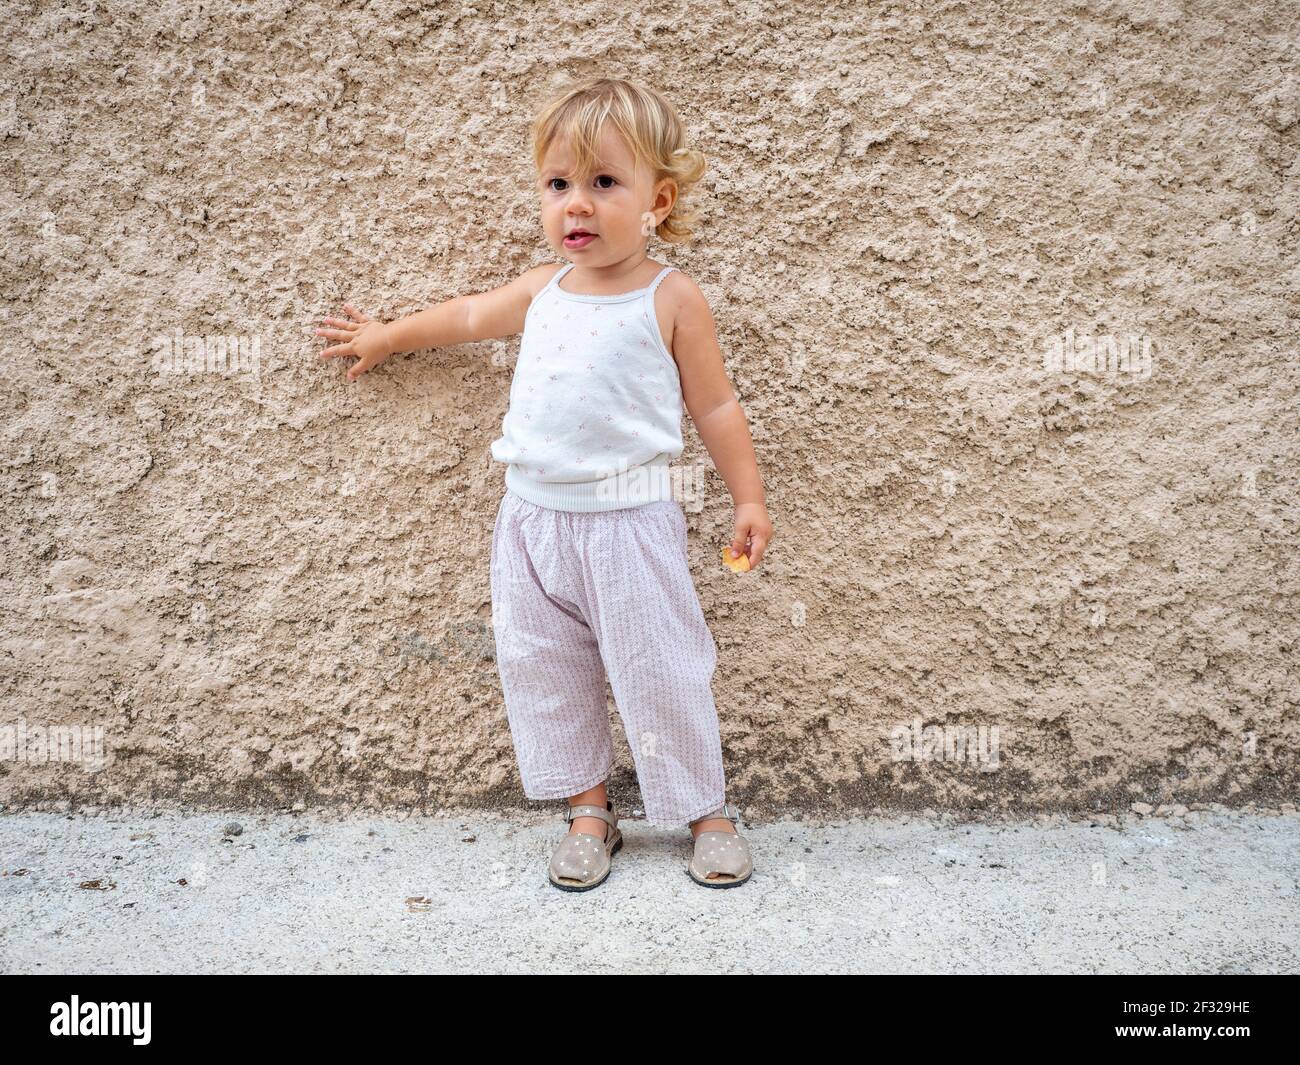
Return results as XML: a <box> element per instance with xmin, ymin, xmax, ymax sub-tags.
<box><xmin>538</xmin><ymin>125</ymin><xmax>676</xmax><ymax>268</ymax></box>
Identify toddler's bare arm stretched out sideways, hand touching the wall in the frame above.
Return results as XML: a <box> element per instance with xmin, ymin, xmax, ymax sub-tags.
<box><xmin>316</xmin><ymin>263</ymin><xmax>556</xmax><ymax>381</ymax></box>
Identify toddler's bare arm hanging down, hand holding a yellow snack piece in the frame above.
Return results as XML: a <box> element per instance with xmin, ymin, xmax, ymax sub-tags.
<box><xmin>668</xmin><ymin>279</ymin><xmax>772</xmax><ymax>570</ymax></box>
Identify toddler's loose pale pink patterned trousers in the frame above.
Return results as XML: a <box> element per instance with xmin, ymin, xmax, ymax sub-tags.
<box><xmin>491</xmin><ymin>489</ymin><xmax>725</xmax><ymax>827</ymax></box>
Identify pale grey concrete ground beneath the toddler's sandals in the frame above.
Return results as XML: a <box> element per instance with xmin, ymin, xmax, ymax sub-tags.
<box><xmin>0</xmin><ymin>806</ymin><xmax>1300</xmax><ymax>974</ymax></box>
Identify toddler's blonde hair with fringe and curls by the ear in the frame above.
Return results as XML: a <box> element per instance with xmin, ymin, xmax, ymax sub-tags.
<box><xmin>532</xmin><ymin>78</ymin><xmax>706</xmax><ymax>244</ymax></box>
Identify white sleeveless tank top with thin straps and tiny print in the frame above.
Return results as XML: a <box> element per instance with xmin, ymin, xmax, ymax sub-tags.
<box><xmin>491</xmin><ymin>263</ymin><xmax>683</xmax><ymax>511</ymax></box>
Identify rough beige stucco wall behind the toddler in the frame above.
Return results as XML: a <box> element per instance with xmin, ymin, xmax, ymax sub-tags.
<box><xmin>0</xmin><ymin>0</ymin><xmax>1300</xmax><ymax>814</ymax></box>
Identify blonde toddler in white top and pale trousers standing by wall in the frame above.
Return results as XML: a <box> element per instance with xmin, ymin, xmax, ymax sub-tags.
<box><xmin>316</xmin><ymin>78</ymin><xmax>772</xmax><ymax>891</ymax></box>
